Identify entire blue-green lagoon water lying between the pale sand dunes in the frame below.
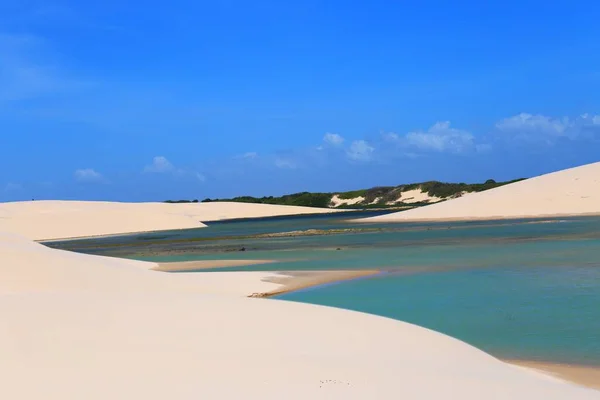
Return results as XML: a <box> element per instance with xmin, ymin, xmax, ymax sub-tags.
<box><xmin>51</xmin><ymin>214</ymin><xmax>600</xmax><ymax>365</ymax></box>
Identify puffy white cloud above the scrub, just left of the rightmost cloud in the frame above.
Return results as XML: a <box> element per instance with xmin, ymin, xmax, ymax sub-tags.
<box><xmin>405</xmin><ymin>121</ymin><xmax>475</xmax><ymax>153</ymax></box>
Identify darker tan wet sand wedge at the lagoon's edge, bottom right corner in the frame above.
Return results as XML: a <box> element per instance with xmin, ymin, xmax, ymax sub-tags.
<box><xmin>501</xmin><ymin>359</ymin><xmax>600</xmax><ymax>390</ymax></box>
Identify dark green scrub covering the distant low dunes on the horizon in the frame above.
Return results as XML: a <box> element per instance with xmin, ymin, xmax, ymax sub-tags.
<box><xmin>166</xmin><ymin>179</ymin><xmax>523</xmax><ymax>209</ymax></box>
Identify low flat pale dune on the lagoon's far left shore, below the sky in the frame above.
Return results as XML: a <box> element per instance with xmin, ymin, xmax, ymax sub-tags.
<box><xmin>0</xmin><ymin>201</ymin><xmax>334</xmax><ymax>240</ymax></box>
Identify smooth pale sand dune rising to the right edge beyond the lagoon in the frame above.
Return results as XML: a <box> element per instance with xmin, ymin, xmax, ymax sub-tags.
<box><xmin>357</xmin><ymin>162</ymin><xmax>600</xmax><ymax>222</ymax></box>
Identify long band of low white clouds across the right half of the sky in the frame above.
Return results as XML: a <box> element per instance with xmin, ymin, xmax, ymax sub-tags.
<box><xmin>262</xmin><ymin>113</ymin><xmax>600</xmax><ymax>169</ymax></box>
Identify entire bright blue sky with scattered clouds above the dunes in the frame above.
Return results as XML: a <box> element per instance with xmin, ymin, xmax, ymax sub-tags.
<box><xmin>0</xmin><ymin>0</ymin><xmax>600</xmax><ymax>201</ymax></box>
